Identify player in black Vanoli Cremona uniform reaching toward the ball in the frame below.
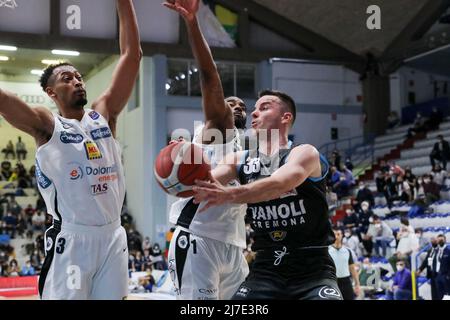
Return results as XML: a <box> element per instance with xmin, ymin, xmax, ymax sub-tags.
<box><xmin>194</xmin><ymin>91</ymin><xmax>342</xmax><ymax>300</ymax></box>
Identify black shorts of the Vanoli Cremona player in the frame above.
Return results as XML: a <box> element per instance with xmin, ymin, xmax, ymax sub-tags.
<box><xmin>232</xmin><ymin>249</ymin><xmax>342</xmax><ymax>300</ymax></box>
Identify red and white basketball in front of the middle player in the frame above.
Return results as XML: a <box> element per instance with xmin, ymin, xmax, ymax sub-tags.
<box><xmin>154</xmin><ymin>141</ymin><xmax>211</xmax><ymax>198</ymax></box>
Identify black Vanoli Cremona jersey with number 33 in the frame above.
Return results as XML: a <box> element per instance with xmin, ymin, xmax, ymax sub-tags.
<box><xmin>238</xmin><ymin>149</ymin><xmax>334</xmax><ymax>251</ymax></box>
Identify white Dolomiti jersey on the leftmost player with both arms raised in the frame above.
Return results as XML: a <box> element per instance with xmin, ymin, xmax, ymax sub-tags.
<box><xmin>36</xmin><ymin>109</ymin><xmax>125</xmax><ymax>226</ymax></box>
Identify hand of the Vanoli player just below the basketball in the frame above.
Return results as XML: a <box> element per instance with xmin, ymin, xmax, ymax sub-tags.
<box><xmin>192</xmin><ymin>172</ymin><xmax>233</xmax><ymax>212</ymax></box>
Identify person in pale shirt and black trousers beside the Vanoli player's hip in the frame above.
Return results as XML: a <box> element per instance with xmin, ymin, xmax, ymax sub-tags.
<box><xmin>328</xmin><ymin>229</ymin><xmax>360</xmax><ymax>300</ymax></box>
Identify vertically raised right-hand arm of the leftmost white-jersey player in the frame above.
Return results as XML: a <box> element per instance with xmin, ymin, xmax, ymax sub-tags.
<box><xmin>93</xmin><ymin>0</ymin><xmax>142</xmax><ymax>132</ymax></box>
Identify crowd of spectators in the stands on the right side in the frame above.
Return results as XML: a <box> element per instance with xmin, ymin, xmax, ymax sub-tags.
<box><xmin>327</xmin><ymin>109</ymin><xmax>450</xmax><ymax>300</ymax></box>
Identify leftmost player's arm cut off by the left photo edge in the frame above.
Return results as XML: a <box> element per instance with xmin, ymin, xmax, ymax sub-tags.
<box><xmin>0</xmin><ymin>89</ymin><xmax>53</xmax><ymax>145</ymax></box>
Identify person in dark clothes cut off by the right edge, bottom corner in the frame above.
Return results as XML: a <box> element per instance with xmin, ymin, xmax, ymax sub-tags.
<box><xmin>436</xmin><ymin>234</ymin><xmax>450</xmax><ymax>299</ymax></box>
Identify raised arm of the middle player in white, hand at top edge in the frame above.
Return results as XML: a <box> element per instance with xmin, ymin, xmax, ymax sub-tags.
<box><xmin>164</xmin><ymin>0</ymin><xmax>234</xmax><ymax>137</ymax></box>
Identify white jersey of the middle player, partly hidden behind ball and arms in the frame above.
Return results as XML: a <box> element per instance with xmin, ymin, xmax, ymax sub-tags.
<box><xmin>169</xmin><ymin>126</ymin><xmax>247</xmax><ymax>248</ymax></box>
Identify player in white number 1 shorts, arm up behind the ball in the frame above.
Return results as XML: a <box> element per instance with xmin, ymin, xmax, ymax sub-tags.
<box><xmin>165</xmin><ymin>0</ymin><xmax>248</xmax><ymax>300</ymax></box>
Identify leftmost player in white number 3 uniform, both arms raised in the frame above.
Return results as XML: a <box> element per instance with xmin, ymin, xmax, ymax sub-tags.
<box><xmin>0</xmin><ymin>0</ymin><xmax>142</xmax><ymax>300</ymax></box>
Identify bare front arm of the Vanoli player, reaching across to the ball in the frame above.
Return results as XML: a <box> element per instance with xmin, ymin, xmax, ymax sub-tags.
<box><xmin>194</xmin><ymin>145</ymin><xmax>320</xmax><ymax>209</ymax></box>
